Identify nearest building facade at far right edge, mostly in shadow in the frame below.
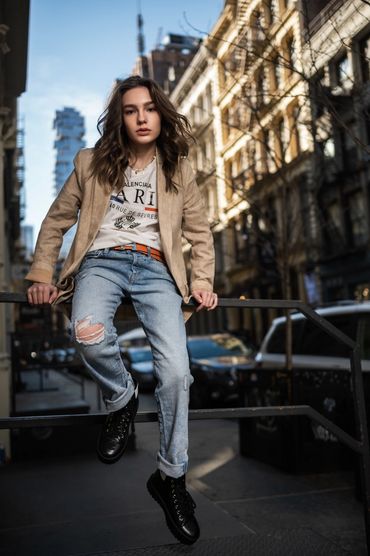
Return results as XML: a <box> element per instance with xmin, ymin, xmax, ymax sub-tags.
<box><xmin>302</xmin><ymin>0</ymin><xmax>370</xmax><ymax>302</ymax></box>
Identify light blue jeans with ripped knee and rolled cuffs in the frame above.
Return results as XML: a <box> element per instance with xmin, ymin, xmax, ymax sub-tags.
<box><xmin>71</xmin><ymin>249</ymin><xmax>193</xmax><ymax>477</ymax></box>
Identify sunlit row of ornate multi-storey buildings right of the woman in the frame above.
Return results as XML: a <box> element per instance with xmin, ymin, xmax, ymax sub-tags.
<box><xmin>171</xmin><ymin>0</ymin><xmax>370</xmax><ymax>344</ymax></box>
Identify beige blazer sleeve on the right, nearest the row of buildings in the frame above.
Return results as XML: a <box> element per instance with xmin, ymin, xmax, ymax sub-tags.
<box><xmin>182</xmin><ymin>160</ymin><xmax>215</xmax><ymax>291</ymax></box>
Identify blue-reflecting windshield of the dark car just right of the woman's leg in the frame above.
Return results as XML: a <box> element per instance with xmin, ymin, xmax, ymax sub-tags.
<box><xmin>188</xmin><ymin>335</ymin><xmax>251</xmax><ymax>359</ymax></box>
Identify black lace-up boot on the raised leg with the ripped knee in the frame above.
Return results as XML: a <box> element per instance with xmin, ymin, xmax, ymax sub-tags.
<box><xmin>96</xmin><ymin>380</ymin><xmax>139</xmax><ymax>463</ymax></box>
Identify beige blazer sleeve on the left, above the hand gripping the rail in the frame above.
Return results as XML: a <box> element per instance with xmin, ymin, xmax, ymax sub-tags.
<box><xmin>25</xmin><ymin>151</ymin><xmax>82</xmax><ymax>284</ymax></box>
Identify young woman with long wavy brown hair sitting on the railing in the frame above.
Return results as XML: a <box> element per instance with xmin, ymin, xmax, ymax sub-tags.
<box><xmin>26</xmin><ymin>76</ymin><xmax>217</xmax><ymax>544</ymax></box>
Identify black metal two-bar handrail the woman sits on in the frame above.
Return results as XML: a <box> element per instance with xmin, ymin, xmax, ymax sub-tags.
<box><xmin>0</xmin><ymin>292</ymin><xmax>370</xmax><ymax>554</ymax></box>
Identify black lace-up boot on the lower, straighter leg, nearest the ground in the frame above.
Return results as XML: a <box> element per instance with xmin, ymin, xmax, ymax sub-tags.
<box><xmin>146</xmin><ymin>469</ymin><xmax>200</xmax><ymax>544</ymax></box>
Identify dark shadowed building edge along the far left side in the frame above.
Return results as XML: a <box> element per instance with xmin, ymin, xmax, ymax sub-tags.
<box><xmin>0</xmin><ymin>0</ymin><xmax>29</xmax><ymax>457</ymax></box>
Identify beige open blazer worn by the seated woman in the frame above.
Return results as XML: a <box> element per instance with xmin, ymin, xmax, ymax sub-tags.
<box><xmin>26</xmin><ymin>149</ymin><xmax>214</xmax><ymax>320</ymax></box>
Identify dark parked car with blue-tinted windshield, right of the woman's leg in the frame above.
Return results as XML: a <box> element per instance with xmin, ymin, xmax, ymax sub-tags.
<box><xmin>188</xmin><ymin>333</ymin><xmax>254</xmax><ymax>409</ymax></box>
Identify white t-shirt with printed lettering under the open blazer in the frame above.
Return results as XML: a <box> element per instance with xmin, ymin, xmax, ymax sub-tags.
<box><xmin>89</xmin><ymin>160</ymin><xmax>161</xmax><ymax>251</ymax></box>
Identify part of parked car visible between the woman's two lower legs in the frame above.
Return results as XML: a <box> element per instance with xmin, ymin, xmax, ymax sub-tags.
<box><xmin>121</xmin><ymin>346</ymin><xmax>156</xmax><ymax>391</ymax></box>
